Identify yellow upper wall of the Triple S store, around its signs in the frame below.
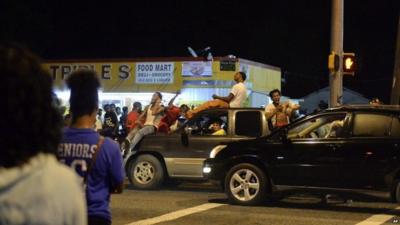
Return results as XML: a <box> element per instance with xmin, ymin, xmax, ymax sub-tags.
<box><xmin>43</xmin><ymin>60</ymin><xmax>281</xmax><ymax>93</ymax></box>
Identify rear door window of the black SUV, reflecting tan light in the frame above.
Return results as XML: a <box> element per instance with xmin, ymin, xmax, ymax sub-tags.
<box><xmin>352</xmin><ymin>113</ymin><xmax>392</xmax><ymax>137</ymax></box>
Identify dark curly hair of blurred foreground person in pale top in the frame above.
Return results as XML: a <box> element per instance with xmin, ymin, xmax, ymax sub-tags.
<box><xmin>0</xmin><ymin>43</ymin><xmax>62</xmax><ymax>168</ymax></box>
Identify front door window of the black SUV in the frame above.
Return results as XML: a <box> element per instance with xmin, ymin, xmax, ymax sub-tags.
<box><xmin>288</xmin><ymin>114</ymin><xmax>346</xmax><ymax>139</ymax></box>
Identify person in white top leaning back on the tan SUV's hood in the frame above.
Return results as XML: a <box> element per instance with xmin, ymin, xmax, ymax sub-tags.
<box><xmin>123</xmin><ymin>92</ymin><xmax>164</xmax><ymax>151</ymax></box>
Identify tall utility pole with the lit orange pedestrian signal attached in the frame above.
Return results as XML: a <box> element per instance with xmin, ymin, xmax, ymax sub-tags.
<box><xmin>329</xmin><ymin>0</ymin><xmax>344</xmax><ymax>107</ymax></box>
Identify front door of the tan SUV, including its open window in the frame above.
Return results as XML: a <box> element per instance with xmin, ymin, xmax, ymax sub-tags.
<box><xmin>164</xmin><ymin>109</ymin><xmax>232</xmax><ymax>178</ymax></box>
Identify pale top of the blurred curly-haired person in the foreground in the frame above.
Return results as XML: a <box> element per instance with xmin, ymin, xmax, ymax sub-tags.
<box><xmin>0</xmin><ymin>153</ymin><xmax>87</xmax><ymax>225</ymax></box>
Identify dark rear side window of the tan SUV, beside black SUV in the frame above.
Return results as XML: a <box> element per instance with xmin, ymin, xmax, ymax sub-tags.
<box><xmin>235</xmin><ymin>111</ymin><xmax>262</xmax><ymax>137</ymax></box>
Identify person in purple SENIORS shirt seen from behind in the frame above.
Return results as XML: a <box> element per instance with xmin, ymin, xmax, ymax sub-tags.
<box><xmin>58</xmin><ymin>70</ymin><xmax>125</xmax><ymax>224</ymax></box>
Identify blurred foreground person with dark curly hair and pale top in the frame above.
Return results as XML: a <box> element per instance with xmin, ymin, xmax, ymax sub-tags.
<box><xmin>0</xmin><ymin>44</ymin><xmax>87</xmax><ymax>225</ymax></box>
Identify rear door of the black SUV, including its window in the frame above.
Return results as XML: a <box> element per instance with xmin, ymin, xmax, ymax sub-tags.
<box><xmin>339</xmin><ymin>112</ymin><xmax>400</xmax><ymax>189</ymax></box>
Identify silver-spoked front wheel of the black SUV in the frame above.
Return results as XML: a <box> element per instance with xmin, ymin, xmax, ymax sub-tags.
<box><xmin>225</xmin><ymin>163</ymin><xmax>267</xmax><ymax>205</ymax></box>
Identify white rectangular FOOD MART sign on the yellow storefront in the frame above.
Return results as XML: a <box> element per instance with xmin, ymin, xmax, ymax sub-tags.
<box><xmin>136</xmin><ymin>62</ymin><xmax>174</xmax><ymax>84</ymax></box>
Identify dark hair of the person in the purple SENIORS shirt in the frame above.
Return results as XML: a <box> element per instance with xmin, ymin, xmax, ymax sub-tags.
<box><xmin>66</xmin><ymin>70</ymin><xmax>100</xmax><ymax>124</ymax></box>
